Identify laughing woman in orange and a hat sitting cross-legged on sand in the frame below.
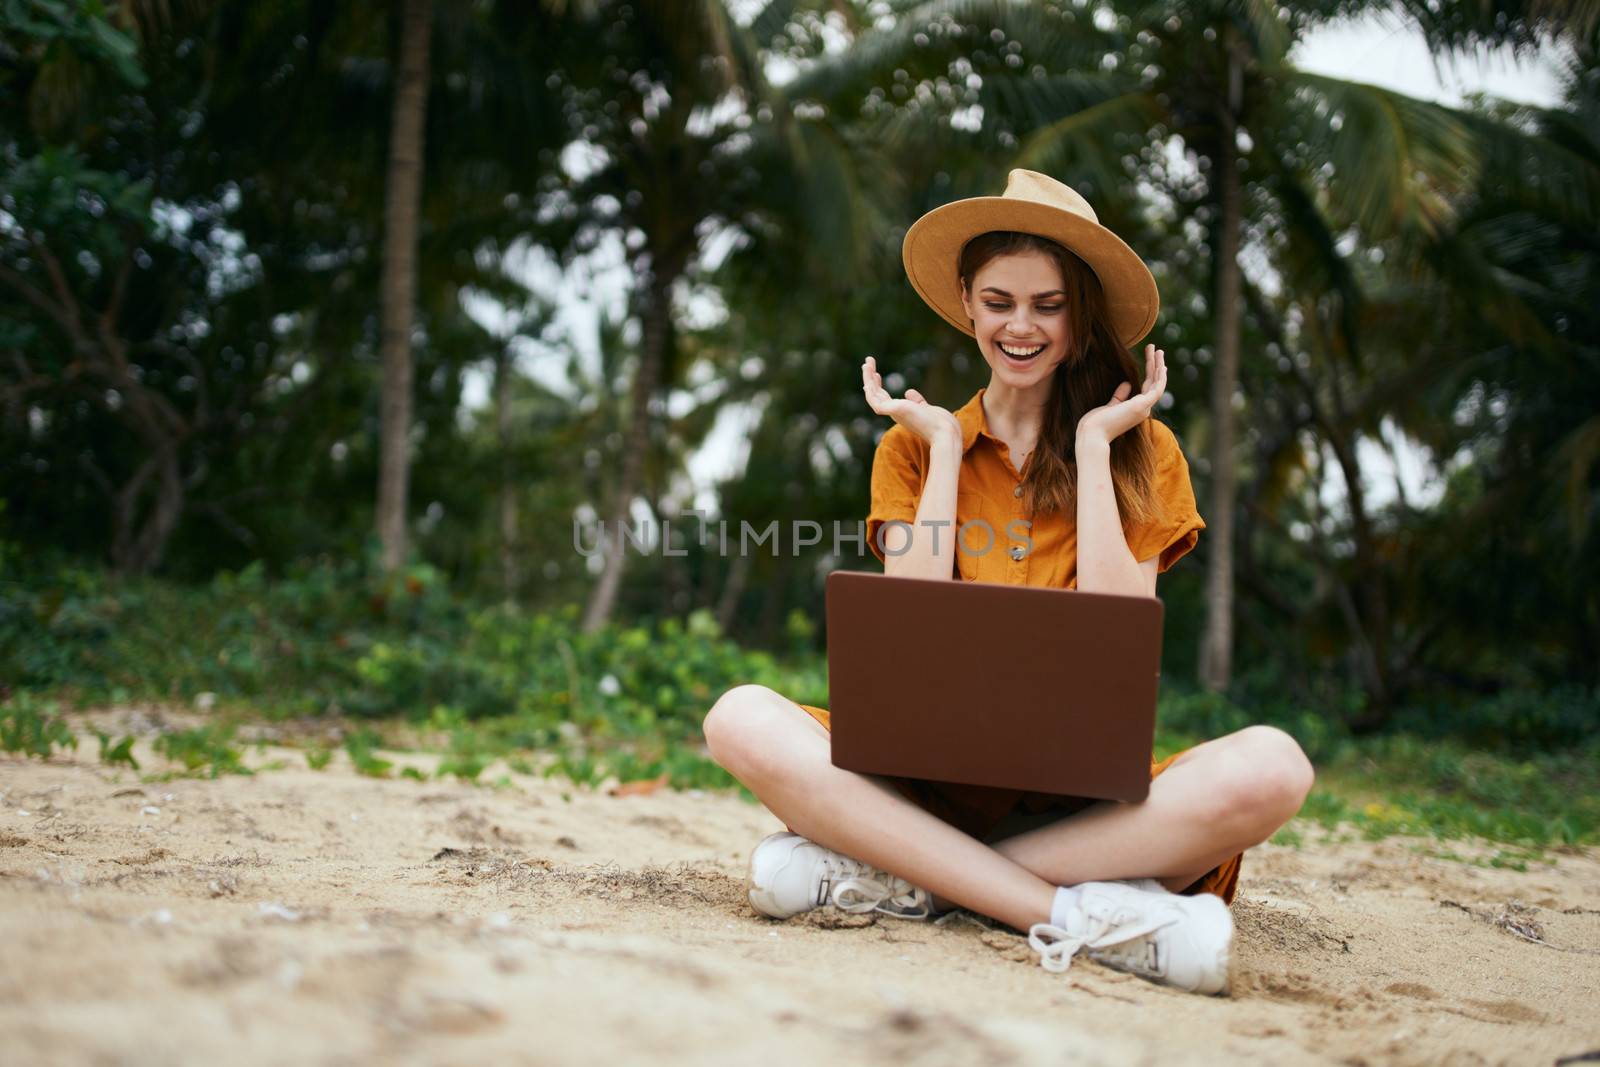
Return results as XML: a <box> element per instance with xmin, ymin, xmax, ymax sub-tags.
<box><xmin>704</xmin><ymin>170</ymin><xmax>1312</xmax><ymax>992</ymax></box>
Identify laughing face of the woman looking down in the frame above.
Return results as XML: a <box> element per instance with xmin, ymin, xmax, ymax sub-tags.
<box><xmin>962</xmin><ymin>253</ymin><xmax>1067</xmax><ymax>389</ymax></box>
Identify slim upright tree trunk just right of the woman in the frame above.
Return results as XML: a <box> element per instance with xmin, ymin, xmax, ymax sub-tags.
<box><xmin>1200</xmin><ymin>45</ymin><xmax>1243</xmax><ymax>693</ymax></box>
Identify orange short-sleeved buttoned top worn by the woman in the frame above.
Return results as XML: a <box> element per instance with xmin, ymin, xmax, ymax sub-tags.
<box><xmin>867</xmin><ymin>389</ymin><xmax>1205</xmax><ymax>589</ymax></box>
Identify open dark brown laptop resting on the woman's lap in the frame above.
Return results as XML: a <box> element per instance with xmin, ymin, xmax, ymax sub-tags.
<box><xmin>826</xmin><ymin>571</ymin><xmax>1162</xmax><ymax>801</ymax></box>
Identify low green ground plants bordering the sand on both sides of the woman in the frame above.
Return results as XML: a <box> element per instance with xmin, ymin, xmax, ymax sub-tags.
<box><xmin>0</xmin><ymin>565</ymin><xmax>1600</xmax><ymax>862</ymax></box>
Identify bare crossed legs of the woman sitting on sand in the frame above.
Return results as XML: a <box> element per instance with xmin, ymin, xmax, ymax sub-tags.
<box><xmin>704</xmin><ymin>685</ymin><xmax>1312</xmax><ymax>929</ymax></box>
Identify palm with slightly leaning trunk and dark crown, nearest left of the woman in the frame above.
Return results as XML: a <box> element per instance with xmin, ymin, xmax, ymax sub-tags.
<box><xmin>556</xmin><ymin>0</ymin><xmax>851</xmax><ymax>632</ymax></box>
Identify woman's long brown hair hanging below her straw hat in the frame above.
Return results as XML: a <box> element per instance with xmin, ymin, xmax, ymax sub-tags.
<box><xmin>958</xmin><ymin>230</ymin><xmax>1162</xmax><ymax>526</ymax></box>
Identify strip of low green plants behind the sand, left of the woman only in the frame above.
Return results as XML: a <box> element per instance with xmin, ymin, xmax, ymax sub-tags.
<box><xmin>0</xmin><ymin>565</ymin><xmax>827</xmax><ymax>751</ymax></box>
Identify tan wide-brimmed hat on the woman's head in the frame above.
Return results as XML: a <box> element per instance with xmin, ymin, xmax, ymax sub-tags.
<box><xmin>901</xmin><ymin>170</ymin><xmax>1162</xmax><ymax>347</ymax></box>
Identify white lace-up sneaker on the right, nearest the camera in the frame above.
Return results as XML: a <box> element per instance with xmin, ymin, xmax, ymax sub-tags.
<box><xmin>1027</xmin><ymin>880</ymin><xmax>1234</xmax><ymax>993</ymax></box>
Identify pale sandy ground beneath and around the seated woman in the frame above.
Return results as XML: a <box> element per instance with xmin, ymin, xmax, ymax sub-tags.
<box><xmin>0</xmin><ymin>713</ymin><xmax>1600</xmax><ymax>1067</ymax></box>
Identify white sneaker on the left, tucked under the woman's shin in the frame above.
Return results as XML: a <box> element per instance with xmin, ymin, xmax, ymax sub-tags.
<box><xmin>750</xmin><ymin>832</ymin><xmax>933</xmax><ymax>918</ymax></box>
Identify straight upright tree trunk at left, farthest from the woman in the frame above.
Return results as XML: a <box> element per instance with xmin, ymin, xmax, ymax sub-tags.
<box><xmin>378</xmin><ymin>0</ymin><xmax>434</xmax><ymax>571</ymax></box>
